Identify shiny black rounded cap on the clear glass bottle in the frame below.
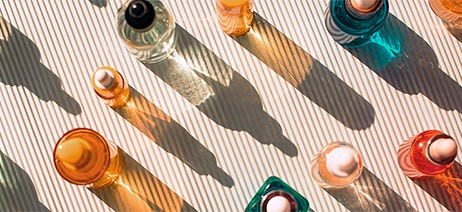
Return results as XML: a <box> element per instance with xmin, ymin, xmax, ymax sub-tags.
<box><xmin>125</xmin><ymin>0</ymin><xmax>156</xmax><ymax>29</ymax></box>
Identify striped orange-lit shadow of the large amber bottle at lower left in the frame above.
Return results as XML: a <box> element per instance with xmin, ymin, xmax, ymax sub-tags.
<box><xmin>88</xmin><ymin>149</ymin><xmax>197</xmax><ymax>212</ymax></box>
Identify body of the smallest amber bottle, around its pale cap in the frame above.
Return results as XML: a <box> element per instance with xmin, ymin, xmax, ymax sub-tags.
<box><xmin>91</xmin><ymin>66</ymin><xmax>130</xmax><ymax>108</ymax></box>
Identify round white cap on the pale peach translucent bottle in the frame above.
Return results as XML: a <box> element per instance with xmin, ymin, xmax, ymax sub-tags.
<box><xmin>326</xmin><ymin>147</ymin><xmax>359</xmax><ymax>177</ymax></box>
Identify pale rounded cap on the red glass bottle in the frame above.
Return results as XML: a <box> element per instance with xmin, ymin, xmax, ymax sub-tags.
<box><xmin>428</xmin><ymin>138</ymin><xmax>457</xmax><ymax>164</ymax></box>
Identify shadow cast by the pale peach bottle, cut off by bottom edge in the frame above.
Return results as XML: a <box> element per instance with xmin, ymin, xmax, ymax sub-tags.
<box><xmin>325</xmin><ymin>168</ymin><xmax>417</xmax><ymax>211</ymax></box>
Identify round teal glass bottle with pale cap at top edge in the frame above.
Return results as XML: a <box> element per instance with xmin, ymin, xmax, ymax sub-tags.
<box><xmin>325</xmin><ymin>0</ymin><xmax>388</xmax><ymax>47</ymax></box>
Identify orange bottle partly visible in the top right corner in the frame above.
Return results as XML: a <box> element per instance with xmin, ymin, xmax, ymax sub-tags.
<box><xmin>428</xmin><ymin>0</ymin><xmax>462</xmax><ymax>29</ymax></box>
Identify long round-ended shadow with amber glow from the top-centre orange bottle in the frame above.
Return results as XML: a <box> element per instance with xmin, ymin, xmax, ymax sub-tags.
<box><xmin>233</xmin><ymin>13</ymin><xmax>375</xmax><ymax>130</ymax></box>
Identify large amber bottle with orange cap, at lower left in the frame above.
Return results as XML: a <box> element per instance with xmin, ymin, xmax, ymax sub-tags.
<box><xmin>53</xmin><ymin>128</ymin><xmax>122</xmax><ymax>188</ymax></box>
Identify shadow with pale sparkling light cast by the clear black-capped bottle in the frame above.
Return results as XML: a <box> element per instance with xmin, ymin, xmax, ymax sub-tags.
<box><xmin>145</xmin><ymin>25</ymin><xmax>298</xmax><ymax>157</ymax></box>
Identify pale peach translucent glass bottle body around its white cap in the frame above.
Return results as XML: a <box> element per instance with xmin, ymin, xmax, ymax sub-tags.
<box><xmin>311</xmin><ymin>142</ymin><xmax>363</xmax><ymax>189</ymax></box>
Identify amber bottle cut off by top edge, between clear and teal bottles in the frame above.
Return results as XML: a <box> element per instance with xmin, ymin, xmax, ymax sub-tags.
<box><xmin>216</xmin><ymin>0</ymin><xmax>253</xmax><ymax>36</ymax></box>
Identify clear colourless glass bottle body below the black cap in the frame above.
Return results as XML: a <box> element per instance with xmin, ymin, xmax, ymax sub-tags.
<box><xmin>117</xmin><ymin>0</ymin><xmax>176</xmax><ymax>63</ymax></box>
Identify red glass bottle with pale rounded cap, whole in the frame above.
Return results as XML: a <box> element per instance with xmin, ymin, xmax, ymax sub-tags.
<box><xmin>397</xmin><ymin>130</ymin><xmax>458</xmax><ymax>178</ymax></box>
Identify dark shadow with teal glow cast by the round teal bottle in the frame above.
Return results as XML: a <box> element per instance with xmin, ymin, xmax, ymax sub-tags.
<box><xmin>345</xmin><ymin>14</ymin><xmax>462</xmax><ymax>113</ymax></box>
